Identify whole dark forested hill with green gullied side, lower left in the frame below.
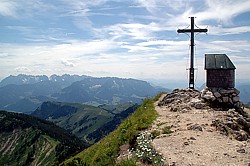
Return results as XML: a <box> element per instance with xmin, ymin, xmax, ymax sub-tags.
<box><xmin>0</xmin><ymin>111</ymin><xmax>89</xmax><ymax>166</ymax></box>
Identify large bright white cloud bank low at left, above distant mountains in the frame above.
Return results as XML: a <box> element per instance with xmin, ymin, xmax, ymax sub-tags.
<box><xmin>0</xmin><ymin>40</ymin><xmax>122</xmax><ymax>73</ymax></box>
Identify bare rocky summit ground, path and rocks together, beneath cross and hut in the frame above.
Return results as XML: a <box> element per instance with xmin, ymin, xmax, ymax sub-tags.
<box><xmin>148</xmin><ymin>89</ymin><xmax>250</xmax><ymax>166</ymax></box>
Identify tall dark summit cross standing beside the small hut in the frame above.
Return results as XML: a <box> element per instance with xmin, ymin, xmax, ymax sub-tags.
<box><xmin>177</xmin><ymin>17</ymin><xmax>207</xmax><ymax>89</ymax></box>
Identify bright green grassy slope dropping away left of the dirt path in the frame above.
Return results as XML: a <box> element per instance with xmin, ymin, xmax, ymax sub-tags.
<box><xmin>64</xmin><ymin>95</ymin><xmax>160</xmax><ymax>166</ymax></box>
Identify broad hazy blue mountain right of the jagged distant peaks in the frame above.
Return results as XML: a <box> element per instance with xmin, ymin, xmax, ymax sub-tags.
<box><xmin>53</xmin><ymin>77</ymin><xmax>157</xmax><ymax>104</ymax></box>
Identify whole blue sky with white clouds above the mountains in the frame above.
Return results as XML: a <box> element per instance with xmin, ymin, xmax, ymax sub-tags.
<box><xmin>0</xmin><ymin>0</ymin><xmax>250</xmax><ymax>86</ymax></box>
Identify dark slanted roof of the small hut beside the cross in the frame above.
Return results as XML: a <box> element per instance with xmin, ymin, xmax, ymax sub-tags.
<box><xmin>205</xmin><ymin>54</ymin><xmax>236</xmax><ymax>70</ymax></box>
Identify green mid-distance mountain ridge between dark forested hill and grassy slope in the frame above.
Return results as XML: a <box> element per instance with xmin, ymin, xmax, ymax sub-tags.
<box><xmin>31</xmin><ymin>102</ymin><xmax>138</xmax><ymax>144</ymax></box>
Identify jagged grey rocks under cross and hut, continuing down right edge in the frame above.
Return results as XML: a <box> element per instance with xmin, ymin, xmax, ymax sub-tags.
<box><xmin>159</xmin><ymin>88</ymin><xmax>250</xmax><ymax>141</ymax></box>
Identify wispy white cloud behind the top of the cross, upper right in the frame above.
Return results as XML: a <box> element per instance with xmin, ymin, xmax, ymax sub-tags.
<box><xmin>163</xmin><ymin>0</ymin><xmax>250</xmax><ymax>26</ymax></box>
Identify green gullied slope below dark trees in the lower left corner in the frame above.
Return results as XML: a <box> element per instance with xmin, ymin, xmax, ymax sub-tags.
<box><xmin>0</xmin><ymin>128</ymin><xmax>59</xmax><ymax>166</ymax></box>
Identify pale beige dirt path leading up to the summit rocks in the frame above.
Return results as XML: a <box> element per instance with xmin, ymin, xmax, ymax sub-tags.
<box><xmin>150</xmin><ymin>96</ymin><xmax>250</xmax><ymax>166</ymax></box>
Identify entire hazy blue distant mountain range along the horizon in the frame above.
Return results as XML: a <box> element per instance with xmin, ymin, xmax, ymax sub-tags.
<box><xmin>0</xmin><ymin>74</ymin><xmax>168</xmax><ymax>113</ymax></box>
